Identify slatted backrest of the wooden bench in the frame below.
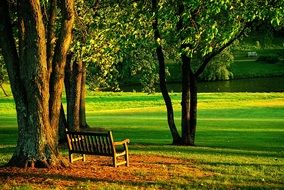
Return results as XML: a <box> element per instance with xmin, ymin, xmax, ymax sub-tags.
<box><xmin>66</xmin><ymin>131</ymin><xmax>114</xmax><ymax>156</ymax></box>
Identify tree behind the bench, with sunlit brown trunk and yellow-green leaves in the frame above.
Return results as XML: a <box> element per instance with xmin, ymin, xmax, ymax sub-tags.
<box><xmin>61</xmin><ymin>0</ymin><xmax>157</xmax><ymax>139</ymax></box>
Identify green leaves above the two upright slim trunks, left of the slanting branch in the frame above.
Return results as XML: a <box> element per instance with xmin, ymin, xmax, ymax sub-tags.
<box><xmin>160</xmin><ymin>1</ymin><xmax>245</xmax><ymax>60</ymax></box>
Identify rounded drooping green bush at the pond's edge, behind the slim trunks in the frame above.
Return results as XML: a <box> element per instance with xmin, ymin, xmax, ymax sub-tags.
<box><xmin>200</xmin><ymin>49</ymin><xmax>234</xmax><ymax>81</ymax></box>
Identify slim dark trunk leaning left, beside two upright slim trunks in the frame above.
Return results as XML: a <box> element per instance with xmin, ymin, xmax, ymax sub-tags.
<box><xmin>152</xmin><ymin>0</ymin><xmax>181</xmax><ymax>145</ymax></box>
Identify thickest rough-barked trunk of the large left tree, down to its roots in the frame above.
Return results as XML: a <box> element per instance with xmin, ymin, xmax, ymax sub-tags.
<box><xmin>1</xmin><ymin>2</ymin><xmax>58</xmax><ymax>166</ymax></box>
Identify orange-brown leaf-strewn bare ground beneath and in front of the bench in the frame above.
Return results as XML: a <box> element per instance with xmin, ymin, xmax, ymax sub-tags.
<box><xmin>0</xmin><ymin>155</ymin><xmax>212</xmax><ymax>189</ymax></box>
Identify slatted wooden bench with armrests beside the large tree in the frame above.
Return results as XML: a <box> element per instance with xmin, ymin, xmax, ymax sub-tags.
<box><xmin>66</xmin><ymin>130</ymin><xmax>130</xmax><ymax>167</ymax></box>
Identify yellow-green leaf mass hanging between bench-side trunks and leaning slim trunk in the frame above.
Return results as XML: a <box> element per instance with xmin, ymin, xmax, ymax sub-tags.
<box><xmin>72</xmin><ymin>1</ymin><xmax>157</xmax><ymax>91</ymax></box>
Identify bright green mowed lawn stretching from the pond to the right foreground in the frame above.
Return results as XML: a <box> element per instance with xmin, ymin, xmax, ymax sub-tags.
<box><xmin>0</xmin><ymin>92</ymin><xmax>284</xmax><ymax>189</ymax></box>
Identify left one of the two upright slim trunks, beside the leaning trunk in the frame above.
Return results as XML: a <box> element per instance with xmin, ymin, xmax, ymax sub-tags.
<box><xmin>181</xmin><ymin>54</ymin><xmax>191</xmax><ymax>145</ymax></box>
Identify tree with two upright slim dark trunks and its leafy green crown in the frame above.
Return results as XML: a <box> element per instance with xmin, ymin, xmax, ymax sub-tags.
<box><xmin>152</xmin><ymin>1</ymin><xmax>272</xmax><ymax>145</ymax></box>
